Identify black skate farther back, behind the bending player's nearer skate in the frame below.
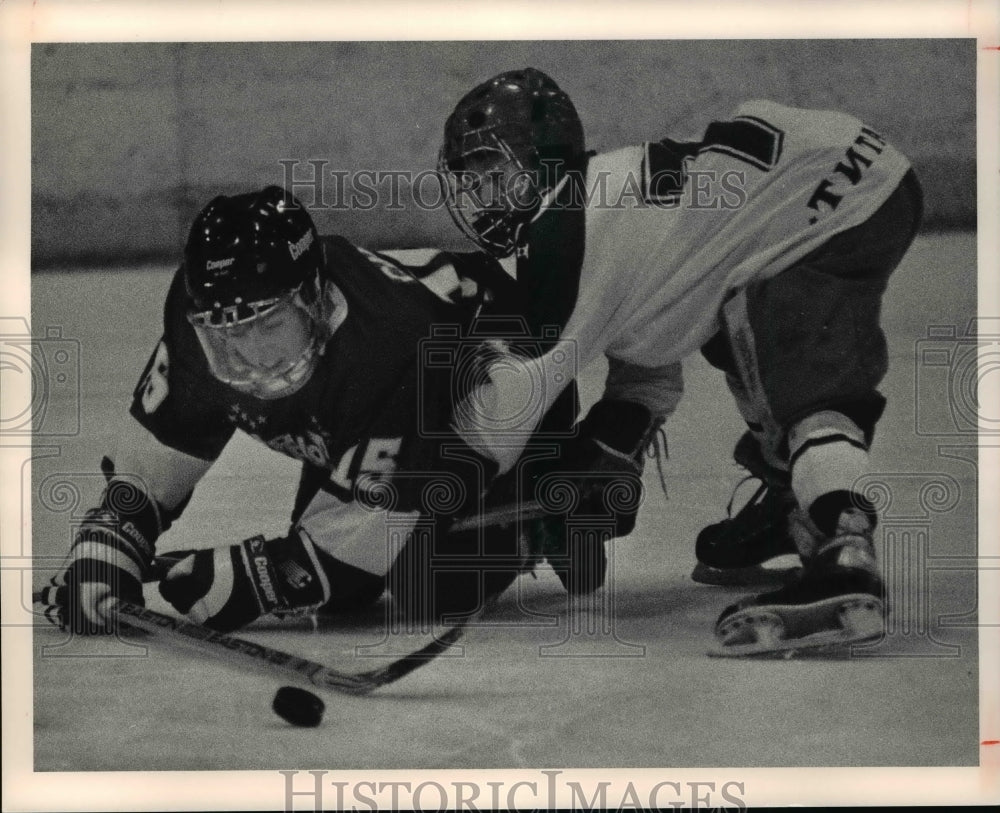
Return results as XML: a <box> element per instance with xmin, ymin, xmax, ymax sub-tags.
<box><xmin>691</xmin><ymin>432</ymin><xmax>801</xmax><ymax>586</ymax></box>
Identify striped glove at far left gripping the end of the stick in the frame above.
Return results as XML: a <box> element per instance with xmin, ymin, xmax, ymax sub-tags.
<box><xmin>42</xmin><ymin>480</ymin><xmax>159</xmax><ymax>635</ymax></box>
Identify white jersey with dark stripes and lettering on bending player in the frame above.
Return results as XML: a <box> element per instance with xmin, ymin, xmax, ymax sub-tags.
<box><xmin>458</xmin><ymin>101</ymin><xmax>910</xmax><ymax>470</ymax></box>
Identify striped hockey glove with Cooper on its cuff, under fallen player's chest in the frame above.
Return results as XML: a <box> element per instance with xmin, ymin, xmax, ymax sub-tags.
<box><xmin>160</xmin><ymin>531</ymin><xmax>330</xmax><ymax>632</ymax></box>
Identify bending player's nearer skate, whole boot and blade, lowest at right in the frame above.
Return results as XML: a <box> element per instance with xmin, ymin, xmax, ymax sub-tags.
<box><xmin>709</xmin><ymin>508</ymin><xmax>885</xmax><ymax>657</ymax></box>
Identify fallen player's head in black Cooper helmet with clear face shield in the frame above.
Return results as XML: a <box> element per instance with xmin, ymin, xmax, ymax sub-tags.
<box><xmin>184</xmin><ymin>186</ymin><xmax>336</xmax><ymax>399</ymax></box>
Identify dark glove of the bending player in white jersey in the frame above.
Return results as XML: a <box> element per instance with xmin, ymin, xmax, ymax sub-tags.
<box><xmin>535</xmin><ymin>399</ymin><xmax>662</xmax><ymax>537</ymax></box>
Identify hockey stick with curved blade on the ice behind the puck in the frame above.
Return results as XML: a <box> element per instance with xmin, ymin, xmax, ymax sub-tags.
<box><xmin>33</xmin><ymin>593</ymin><xmax>468</xmax><ymax>695</ymax></box>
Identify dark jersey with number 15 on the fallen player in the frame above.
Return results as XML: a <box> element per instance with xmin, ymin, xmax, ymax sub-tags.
<box><xmin>131</xmin><ymin>237</ymin><xmax>517</xmax><ymax>510</ymax></box>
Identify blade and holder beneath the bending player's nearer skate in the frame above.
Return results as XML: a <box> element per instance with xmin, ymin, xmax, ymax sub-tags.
<box><xmin>707</xmin><ymin>593</ymin><xmax>885</xmax><ymax>658</ymax></box>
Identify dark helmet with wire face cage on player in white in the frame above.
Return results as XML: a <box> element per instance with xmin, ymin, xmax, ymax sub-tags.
<box><xmin>438</xmin><ymin>68</ymin><xmax>585</xmax><ymax>257</ymax></box>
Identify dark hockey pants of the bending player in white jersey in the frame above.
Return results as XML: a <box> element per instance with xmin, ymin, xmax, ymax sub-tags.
<box><xmin>702</xmin><ymin>170</ymin><xmax>922</xmax><ymax>465</ymax></box>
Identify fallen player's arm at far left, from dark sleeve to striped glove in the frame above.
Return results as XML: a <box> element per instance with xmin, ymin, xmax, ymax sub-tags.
<box><xmin>45</xmin><ymin>275</ymin><xmax>234</xmax><ymax>633</ymax></box>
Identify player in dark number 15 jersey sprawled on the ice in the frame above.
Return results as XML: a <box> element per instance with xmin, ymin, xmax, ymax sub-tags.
<box><xmin>46</xmin><ymin>187</ymin><xmax>603</xmax><ymax>633</ymax></box>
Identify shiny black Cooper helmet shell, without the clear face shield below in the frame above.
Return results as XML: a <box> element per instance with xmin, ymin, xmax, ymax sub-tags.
<box><xmin>184</xmin><ymin>186</ymin><xmax>323</xmax><ymax>324</ymax></box>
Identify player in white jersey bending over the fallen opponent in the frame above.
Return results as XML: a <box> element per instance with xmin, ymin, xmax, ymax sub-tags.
<box><xmin>439</xmin><ymin>68</ymin><xmax>921</xmax><ymax>655</ymax></box>
